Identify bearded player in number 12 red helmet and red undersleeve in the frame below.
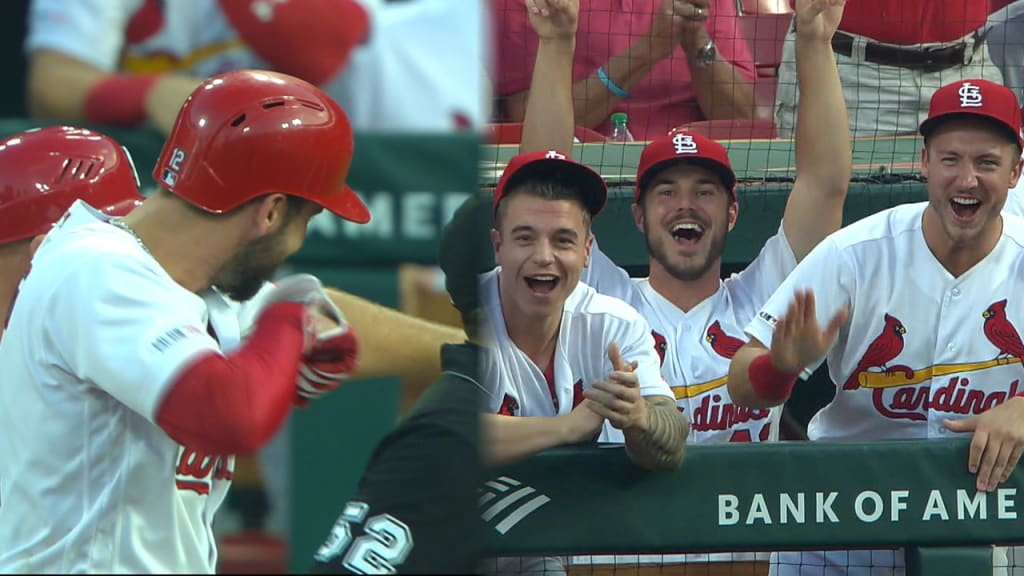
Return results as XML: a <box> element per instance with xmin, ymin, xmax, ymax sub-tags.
<box><xmin>0</xmin><ymin>72</ymin><xmax>369</xmax><ymax>573</ymax></box>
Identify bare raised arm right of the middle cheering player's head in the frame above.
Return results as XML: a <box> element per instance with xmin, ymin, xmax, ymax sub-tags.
<box><xmin>782</xmin><ymin>0</ymin><xmax>852</xmax><ymax>261</ymax></box>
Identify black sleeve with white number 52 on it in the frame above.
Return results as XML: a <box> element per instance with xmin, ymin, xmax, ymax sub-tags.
<box><xmin>312</xmin><ymin>362</ymin><xmax>483</xmax><ymax>574</ymax></box>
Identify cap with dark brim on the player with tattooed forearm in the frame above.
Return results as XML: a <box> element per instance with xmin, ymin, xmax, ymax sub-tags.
<box><xmin>495</xmin><ymin>150</ymin><xmax>608</xmax><ymax>217</ymax></box>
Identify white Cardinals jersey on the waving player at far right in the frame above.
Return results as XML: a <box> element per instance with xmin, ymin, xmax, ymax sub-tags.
<box><xmin>746</xmin><ymin>202</ymin><xmax>1024</xmax><ymax>576</ymax></box>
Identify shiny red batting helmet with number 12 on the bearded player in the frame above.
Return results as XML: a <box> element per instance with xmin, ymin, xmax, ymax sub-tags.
<box><xmin>153</xmin><ymin>70</ymin><xmax>370</xmax><ymax>223</ymax></box>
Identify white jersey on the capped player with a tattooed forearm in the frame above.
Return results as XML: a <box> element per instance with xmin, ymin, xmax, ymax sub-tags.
<box><xmin>480</xmin><ymin>269</ymin><xmax>672</xmax><ymax>442</ymax></box>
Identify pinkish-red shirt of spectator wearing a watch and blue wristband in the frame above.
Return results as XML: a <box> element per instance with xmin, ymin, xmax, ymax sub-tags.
<box><xmin>492</xmin><ymin>0</ymin><xmax>757</xmax><ymax>140</ymax></box>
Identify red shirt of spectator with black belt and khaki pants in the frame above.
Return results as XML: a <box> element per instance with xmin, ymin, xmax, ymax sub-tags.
<box><xmin>790</xmin><ymin>0</ymin><xmax>990</xmax><ymax>45</ymax></box>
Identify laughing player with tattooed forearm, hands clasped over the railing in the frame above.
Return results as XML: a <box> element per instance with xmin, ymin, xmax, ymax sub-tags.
<box><xmin>480</xmin><ymin>146</ymin><xmax>687</xmax><ymax>461</ymax></box>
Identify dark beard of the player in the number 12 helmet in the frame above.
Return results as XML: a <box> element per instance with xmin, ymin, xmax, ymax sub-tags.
<box><xmin>211</xmin><ymin>227</ymin><xmax>287</xmax><ymax>302</ymax></box>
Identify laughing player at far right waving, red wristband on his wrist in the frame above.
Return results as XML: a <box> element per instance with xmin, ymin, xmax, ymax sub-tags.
<box><xmin>729</xmin><ymin>80</ymin><xmax>1024</xmax><ymax>576</ymax></box>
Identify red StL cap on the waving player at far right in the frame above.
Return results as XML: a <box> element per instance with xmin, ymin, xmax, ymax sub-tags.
<box><xmin>920</xmin><ymin>80</ymin><xmax>1024</xmax><ymax>149</ymax></box>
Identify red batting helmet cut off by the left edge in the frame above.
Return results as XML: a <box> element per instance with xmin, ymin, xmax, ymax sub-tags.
<box><xmin>0</xmin><ymin>126</ymin><xmax>142</xmax><ymax>244</ymax></box>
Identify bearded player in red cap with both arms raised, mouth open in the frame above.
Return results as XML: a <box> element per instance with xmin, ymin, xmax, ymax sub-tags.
<box><xmin>522</xmin><ymin>0</ymin><xmax>851</xmax><ymax>563</ymax></box>
